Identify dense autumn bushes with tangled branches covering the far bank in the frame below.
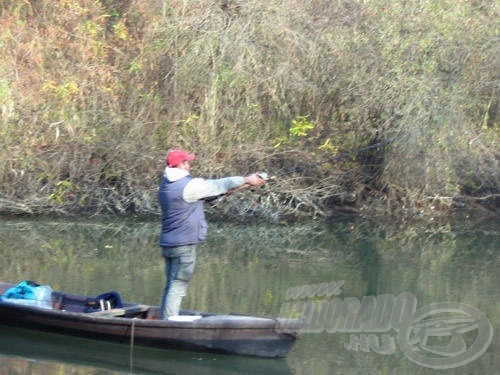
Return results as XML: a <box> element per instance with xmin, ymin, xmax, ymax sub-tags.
<box><xmin>0</xmin><ymin>0</ymin><xmax>500</xmax><ymax>218</ymax></box>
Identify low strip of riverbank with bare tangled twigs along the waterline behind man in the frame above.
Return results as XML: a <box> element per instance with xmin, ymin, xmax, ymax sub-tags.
<box><xmin>0</xmin><ymin>188</ymin><xmax>500</xmax><ymax>223</ymax></box>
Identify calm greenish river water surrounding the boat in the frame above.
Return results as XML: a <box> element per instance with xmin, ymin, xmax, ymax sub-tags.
<box><xmin>0</xmin><ymin>219</ymin><xmax>500</xmax><ymax>374</ymax></box>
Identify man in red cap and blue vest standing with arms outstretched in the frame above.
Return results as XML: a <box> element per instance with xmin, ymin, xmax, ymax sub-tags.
<box><xmin>158</xmin><ymin>150</ymin><xmax>265</xmax><ymax>319</ymax></box>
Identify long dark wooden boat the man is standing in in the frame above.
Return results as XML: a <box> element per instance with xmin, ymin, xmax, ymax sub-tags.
<box><xmin>0</xmin><ymin>283</ymin><xmax>300</xmax><ymax>358</ymax></box>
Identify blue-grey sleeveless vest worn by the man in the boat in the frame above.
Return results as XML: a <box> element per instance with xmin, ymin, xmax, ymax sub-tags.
<box><xmin>158</xmin><ymin>176</ymin><xmax>207</xmax><ymax>247</ymax></box>
